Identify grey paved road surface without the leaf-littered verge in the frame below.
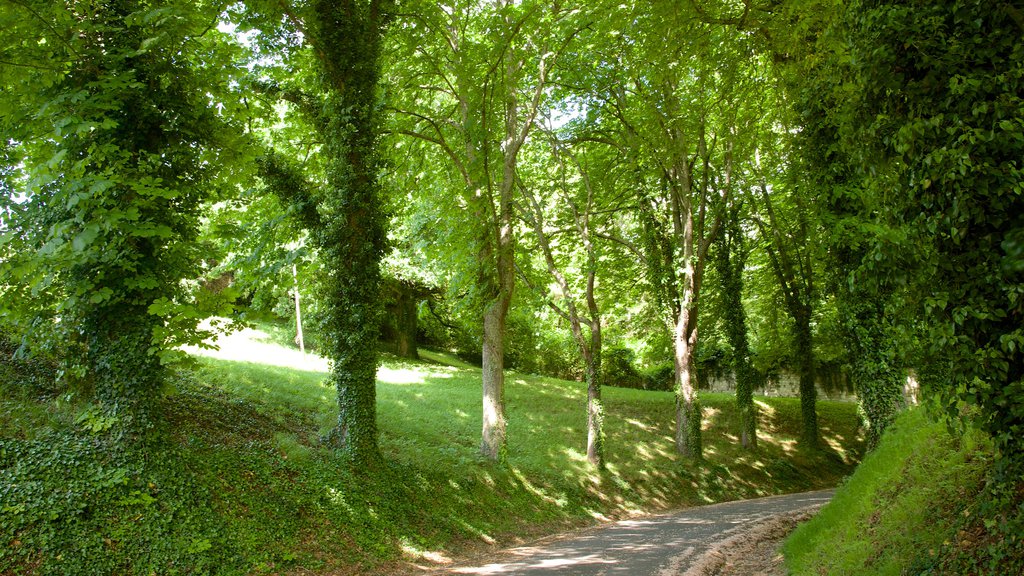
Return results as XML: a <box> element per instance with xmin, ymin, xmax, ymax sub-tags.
<box><xmin>441</xmin><ymin>490</ymin><xmax>835</xmax><ymax>576</ymax></box>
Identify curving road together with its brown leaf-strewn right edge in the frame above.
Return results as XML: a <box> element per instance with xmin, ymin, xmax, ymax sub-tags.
<box><xmin>441</xmin><ymin>490</ymin><xmax>834</xmax><ymax>576</ymax></box>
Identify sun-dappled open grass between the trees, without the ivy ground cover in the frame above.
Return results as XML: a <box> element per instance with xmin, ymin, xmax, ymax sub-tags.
<box><xmin>174</xmin><ymin>323</ymin><xmax>859</xmax><ymax>569</ymax></box>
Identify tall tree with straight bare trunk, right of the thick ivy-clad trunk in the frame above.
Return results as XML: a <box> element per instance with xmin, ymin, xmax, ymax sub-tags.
<box><xmin>392</xmin><ymin>0</ymin><xmax>577</xmax><ymax>460</ymax></box>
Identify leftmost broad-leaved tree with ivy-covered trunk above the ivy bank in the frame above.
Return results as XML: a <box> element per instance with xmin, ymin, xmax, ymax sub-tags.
<box><xmin>0</xmin><ymin>0</ymin><xmax>231</xmax><ymax>430</ymax></box>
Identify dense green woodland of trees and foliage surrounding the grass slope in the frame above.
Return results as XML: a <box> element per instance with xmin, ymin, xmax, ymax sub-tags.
<box><xmin>0</xmin><ymin>0</ymin><xmax>1024</xmax><ymax>573</ymax></box>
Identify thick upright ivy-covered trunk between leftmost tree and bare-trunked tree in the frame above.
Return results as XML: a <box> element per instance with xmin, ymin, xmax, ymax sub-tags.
<box><xmin>308</xmin><ymin>0</ymin><xmax>391</xmax><ymax>464</ymax></box>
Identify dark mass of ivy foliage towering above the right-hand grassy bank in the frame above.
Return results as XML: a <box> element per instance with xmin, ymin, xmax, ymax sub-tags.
<box><xmin>790</xmin><ymin>0</ymin><xmax>1024</xmax><ymax>473</ymax></box>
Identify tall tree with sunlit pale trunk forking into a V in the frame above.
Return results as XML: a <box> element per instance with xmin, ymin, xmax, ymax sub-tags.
<box><xmin>596</xmin><ymin>3</ymin><xmax>765</xmax><ymax>458</ymax></box>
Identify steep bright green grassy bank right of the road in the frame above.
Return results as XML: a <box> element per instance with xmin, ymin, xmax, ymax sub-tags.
<box><xmin>784</xmin><ymin>409</ymin><xmax>1007</xmax><ymax>575</ymax></box>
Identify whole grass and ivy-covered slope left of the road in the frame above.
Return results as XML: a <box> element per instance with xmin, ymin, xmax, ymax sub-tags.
<box><xmin>0</xmin><ymin>325</ymin><xmax>861</xmax><ymax>574</ymax></box>
